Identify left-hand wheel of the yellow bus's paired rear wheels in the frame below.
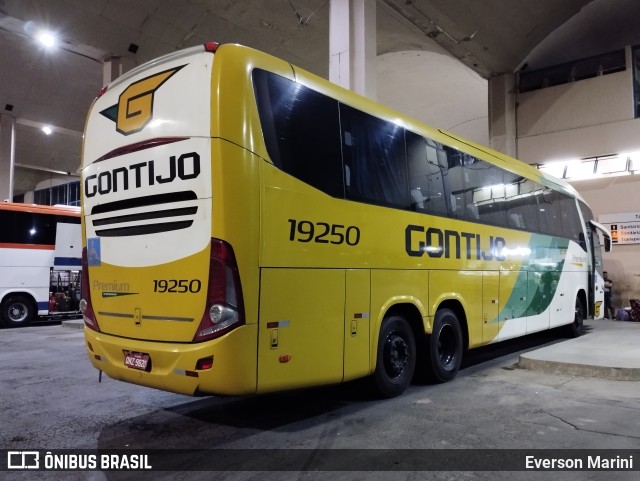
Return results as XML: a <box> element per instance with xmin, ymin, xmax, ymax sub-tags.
<box><xmin>373</xmin><ymin>316</ymin><xmax>416</xmax><ymax>398</ymax></box>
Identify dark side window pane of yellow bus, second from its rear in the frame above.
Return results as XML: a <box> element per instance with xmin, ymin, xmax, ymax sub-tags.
<box><xmin>340</xmin><ymin>104</ymin><xmax>411</xmax><ymax>209</ymax></box>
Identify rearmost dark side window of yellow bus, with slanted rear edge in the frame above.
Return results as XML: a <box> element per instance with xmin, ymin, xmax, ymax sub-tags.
<box><xmin>253</xmin><ymin>69</ymin><xmax>344</xmax><ymax>197</ymax></box>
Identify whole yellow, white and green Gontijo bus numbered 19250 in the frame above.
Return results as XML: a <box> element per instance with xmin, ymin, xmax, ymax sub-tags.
<box><xmin>82</xmin><ymin>43</ymin><xmax>609</xmax><ymax>396</ymax></box>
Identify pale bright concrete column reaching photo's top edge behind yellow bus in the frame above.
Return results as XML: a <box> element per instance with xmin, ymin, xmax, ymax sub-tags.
<box><xmin>329</xmin><ymin>0</ymin><xmax>377</xmax><ymax>100</ymax></box>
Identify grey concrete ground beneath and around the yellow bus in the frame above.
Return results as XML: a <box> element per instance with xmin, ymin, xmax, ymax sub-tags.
<box><xmin>0</xmin><ymin>321</ymin><xmax>640</xmax><ymax>481</ymax></box>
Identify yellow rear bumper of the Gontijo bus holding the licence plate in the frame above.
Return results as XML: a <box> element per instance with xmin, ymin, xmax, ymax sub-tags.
<box><xmin>84</xmin><ymin>324</ymin><xmax>258</xmax><ymax>396</ymax></box>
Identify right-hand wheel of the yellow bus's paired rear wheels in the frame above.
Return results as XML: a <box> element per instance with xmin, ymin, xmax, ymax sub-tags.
<box><xmin>429</xmin><ymin>309</ymin><xmax>463</xmax><ymax>382</ymax></box>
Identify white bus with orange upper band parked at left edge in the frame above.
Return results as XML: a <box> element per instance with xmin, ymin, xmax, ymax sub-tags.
<box><xmin>0</xmin><ymin>202</ymin><xmax>82</xmax><ymax>327</ymax></box>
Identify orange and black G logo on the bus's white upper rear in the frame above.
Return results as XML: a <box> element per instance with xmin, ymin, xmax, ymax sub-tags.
<box><xmin>100</xmin><ymin>65</ymin><xmax>185</xmax><ymax>135</ymax></box>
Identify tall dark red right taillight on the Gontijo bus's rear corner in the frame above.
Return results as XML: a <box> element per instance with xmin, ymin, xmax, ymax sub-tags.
<box><xmin>193</xmin><ymin>239</ymin><xmax>244</xmax><ymax>342</ymax></box>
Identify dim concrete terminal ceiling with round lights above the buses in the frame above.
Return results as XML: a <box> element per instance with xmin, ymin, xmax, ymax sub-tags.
<box><xmin>0</xmin><ymin>0</ymin><xmax>640</xmax><ymax>194</ymax></box>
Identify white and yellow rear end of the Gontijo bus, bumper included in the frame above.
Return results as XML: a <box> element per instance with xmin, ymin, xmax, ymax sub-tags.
<box><xmin>81</xmin><ymin>44</ymin><xmax>256</xmax><ymax>395</ymax></box>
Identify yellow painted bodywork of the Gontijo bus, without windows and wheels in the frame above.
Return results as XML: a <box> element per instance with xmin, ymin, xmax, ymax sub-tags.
<box><xmin>83</xmin><ymin>45</ymin><xmax>596</xmax><ymax>395</ymax></box>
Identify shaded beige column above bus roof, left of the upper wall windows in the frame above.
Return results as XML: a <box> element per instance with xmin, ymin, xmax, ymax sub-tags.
<box><xmin>489</xmin><ymin>74</ymin><xmax>518</xmax><ymax>157</ymax></box>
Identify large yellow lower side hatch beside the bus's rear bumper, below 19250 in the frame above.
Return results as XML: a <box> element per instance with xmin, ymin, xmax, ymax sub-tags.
<box><xmin>258</xmin><ymin>268</ymin><xmax>350</xmax><ymax>392</ymax></box>
